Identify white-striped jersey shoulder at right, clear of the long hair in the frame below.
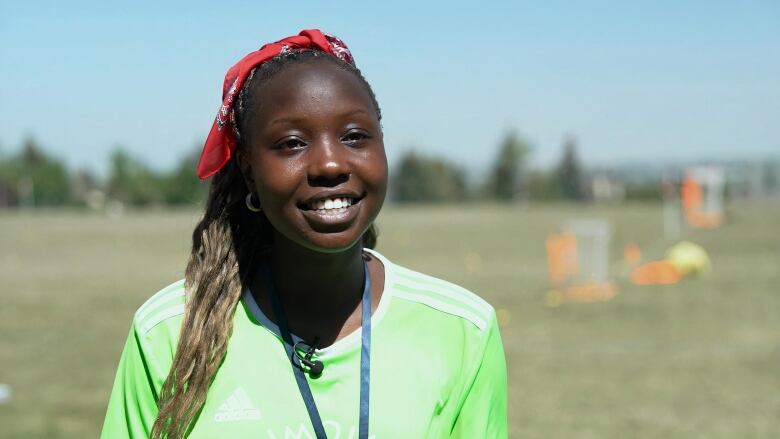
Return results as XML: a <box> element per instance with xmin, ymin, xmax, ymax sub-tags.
<box><xmin>370</xmin><ymin>251</ymin><xmax>495</xmax><ymax>332</ymax></box>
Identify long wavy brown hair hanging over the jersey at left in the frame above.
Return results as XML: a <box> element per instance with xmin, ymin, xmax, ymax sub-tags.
<box><xmin>151</xmin><ymin>163</ymin><xmax>268</xmax><ymax>438</ymax></box>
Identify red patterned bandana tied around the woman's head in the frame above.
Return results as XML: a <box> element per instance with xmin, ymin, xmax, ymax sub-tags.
<box><xmin>198</xmin><ymin>29</ymin><xmax>355</xmax><ymax>180</ymax></box>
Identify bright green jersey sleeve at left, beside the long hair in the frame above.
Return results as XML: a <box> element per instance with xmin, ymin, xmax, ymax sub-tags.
<box><xmin>100</xmin><ymin>325</ymin><xmax>157</xmax><ymax>439</ymax></box>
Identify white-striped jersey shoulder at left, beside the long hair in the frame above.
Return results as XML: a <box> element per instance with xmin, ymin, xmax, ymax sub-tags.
<box><xmin>133</xmin><ymin>279</ymin><xmax>185</xmax><ymax>336</ymax></box>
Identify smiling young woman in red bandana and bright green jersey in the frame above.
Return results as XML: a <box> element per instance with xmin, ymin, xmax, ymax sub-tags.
<box><xmin>103</xmin><ymin>30</ymin><xmax>507</xmax><ymax>439</ymax></box>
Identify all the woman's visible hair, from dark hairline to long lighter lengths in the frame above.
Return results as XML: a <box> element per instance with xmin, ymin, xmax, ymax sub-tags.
<box><xmin>150</xmin><ymin>50</ymin><xmax>380</xmax><ymax>439</ymax></box>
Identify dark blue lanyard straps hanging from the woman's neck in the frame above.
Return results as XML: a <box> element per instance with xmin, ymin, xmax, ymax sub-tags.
<box><xmin>263</xmin><ymin>261</ymin><xmax>371</xmax><ymax>439</ymax></box>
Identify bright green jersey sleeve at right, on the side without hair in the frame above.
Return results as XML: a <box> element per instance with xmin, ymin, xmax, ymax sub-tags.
<box><xmin>451</xmin><ymin>314</ymin><xmax>508</xmax><ymax>439</ymax></box>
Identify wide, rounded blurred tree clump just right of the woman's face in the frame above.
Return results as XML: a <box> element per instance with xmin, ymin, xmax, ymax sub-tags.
<box><xmin>393</xmin><ymin>151</ymin><xmax>468</xmax><ymax>202</ymax></box>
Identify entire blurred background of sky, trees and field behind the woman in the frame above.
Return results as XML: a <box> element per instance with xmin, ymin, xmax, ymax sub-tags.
<box><xmin>0</xmin><ymin>1</ymin><xmax>780</xmax><ymax>438</ymax></box>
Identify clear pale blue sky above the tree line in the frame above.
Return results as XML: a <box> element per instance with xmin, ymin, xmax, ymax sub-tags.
<box><xmin>0</xmin><ymin>1</ymin><xmax>780</xmax><ymax>177</ymax></box>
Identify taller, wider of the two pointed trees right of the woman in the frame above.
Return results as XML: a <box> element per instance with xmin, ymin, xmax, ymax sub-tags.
<box><xmin>488</xmin><ymin>131</ymin><xmax>530</xmax><ymax>201</ymax></box>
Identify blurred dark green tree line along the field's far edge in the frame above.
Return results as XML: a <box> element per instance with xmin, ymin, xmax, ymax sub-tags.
<box><xmin>0</xmin><ymin>132</ymin><xmax>644</xmax><ymax>206</ymax></box>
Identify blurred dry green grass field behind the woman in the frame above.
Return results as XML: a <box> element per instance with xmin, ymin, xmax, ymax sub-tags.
<box><xmin>0</xmin><ymin>204</ymin><xmax>780</xmax><ymax>439</ymax></box>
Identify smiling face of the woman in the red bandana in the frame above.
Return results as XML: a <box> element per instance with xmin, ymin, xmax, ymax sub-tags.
<box><xmin>239</xmin><ymin>61</ymin><xmax>387</xmax><ymax>252</ymax></box>
